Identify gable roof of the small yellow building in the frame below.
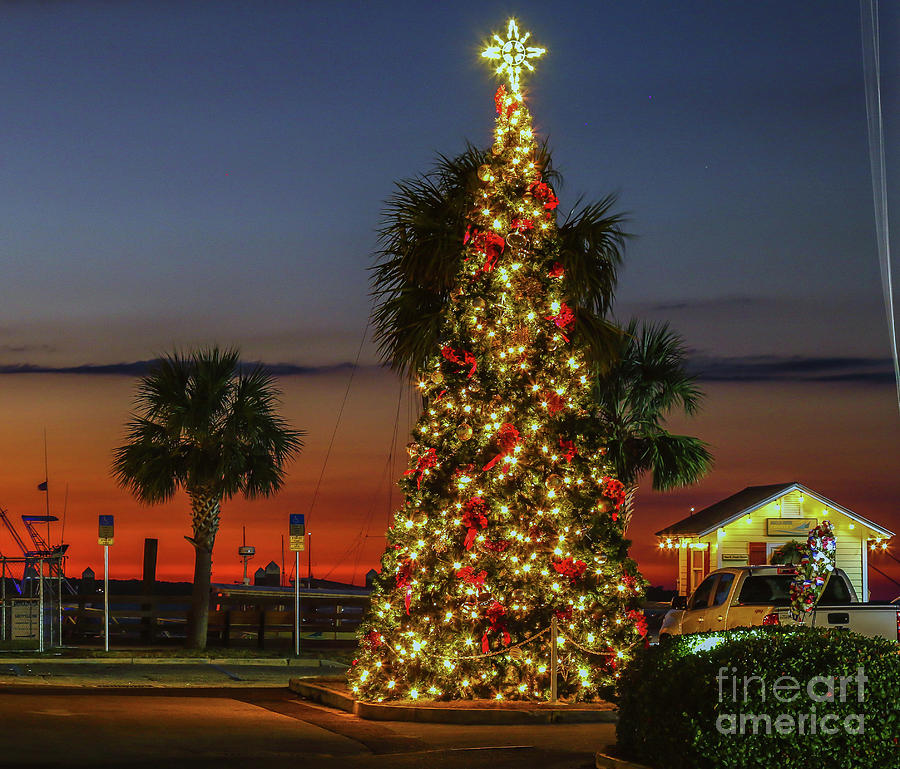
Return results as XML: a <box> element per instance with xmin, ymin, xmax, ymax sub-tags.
<box><xmin>656</xmin><ymin>481</ymin><xmax>894</xmax><ymax>537</ymax></box>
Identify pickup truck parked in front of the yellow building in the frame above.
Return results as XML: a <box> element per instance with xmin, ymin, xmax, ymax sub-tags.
<box><xmin>659</xmin><ymin>566</ymin><xmax>900</xmax><ymax>641</ymax></box>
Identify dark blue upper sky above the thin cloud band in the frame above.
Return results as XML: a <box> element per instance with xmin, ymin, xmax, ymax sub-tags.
<box><xmin>0</xmin><ymin>0</ymin><xmax>898</xmax><ymax>372</ymax></box>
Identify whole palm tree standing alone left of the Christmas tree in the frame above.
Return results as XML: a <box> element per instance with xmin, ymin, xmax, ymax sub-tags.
<box><xmin>112</xmin><ymin>347</ymin><xmax>303</xmax><ymax>649</ymax></box>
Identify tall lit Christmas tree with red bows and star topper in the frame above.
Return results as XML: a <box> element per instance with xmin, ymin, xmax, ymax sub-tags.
<box><xmin>349</xmin><ymin>21</ymin><xmax>646</xmax><ymax>701</ymax></box>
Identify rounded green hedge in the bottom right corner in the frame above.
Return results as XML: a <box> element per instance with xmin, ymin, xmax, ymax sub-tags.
<box><xmin>617</xmin><ymin>627</ymin><xmax>900</xmax><ymax>769</ymax></box>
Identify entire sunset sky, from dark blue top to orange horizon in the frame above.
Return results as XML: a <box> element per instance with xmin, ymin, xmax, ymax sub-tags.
<box><xmin>0</xmin><ymin>0</ymin><xmax>900</xmax><ymax>597</ymax></box>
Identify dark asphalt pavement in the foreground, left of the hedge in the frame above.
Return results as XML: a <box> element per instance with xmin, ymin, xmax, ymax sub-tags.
<box><xmin>0</xmin><ymin>684</ymin><xmax>615</xmax><ymax>769</ymax></box>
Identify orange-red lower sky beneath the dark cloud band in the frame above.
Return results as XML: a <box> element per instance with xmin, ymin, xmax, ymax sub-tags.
<box><xmin>0</xmin><ymin>370</ymin><xmax>900</xmax><ymax>597</ymax></box>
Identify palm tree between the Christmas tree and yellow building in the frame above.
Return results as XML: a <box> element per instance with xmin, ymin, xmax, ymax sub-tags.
<box><xmin>594</xmin><ymin>320</ymin><xmax>713</xmax><ymax>530</ymax></box>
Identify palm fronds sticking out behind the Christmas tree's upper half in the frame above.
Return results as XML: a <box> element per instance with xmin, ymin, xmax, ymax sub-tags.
<box><xmin>371</xmin><ymin>144</ymin><xmax>628</xmax><ymax>374</ymax></box>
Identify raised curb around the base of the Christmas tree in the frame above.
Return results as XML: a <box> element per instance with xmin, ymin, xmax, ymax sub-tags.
<box><xmin>288</xmin><ymin>677</ymin><xmax>618</xmax><ymax>725</ymax></box>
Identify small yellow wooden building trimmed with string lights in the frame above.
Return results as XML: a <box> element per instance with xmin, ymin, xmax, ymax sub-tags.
<box><xmin>656</xmin><ymin>482</ymin><xmax>894</xmax><ymax>601</ymax></box>
